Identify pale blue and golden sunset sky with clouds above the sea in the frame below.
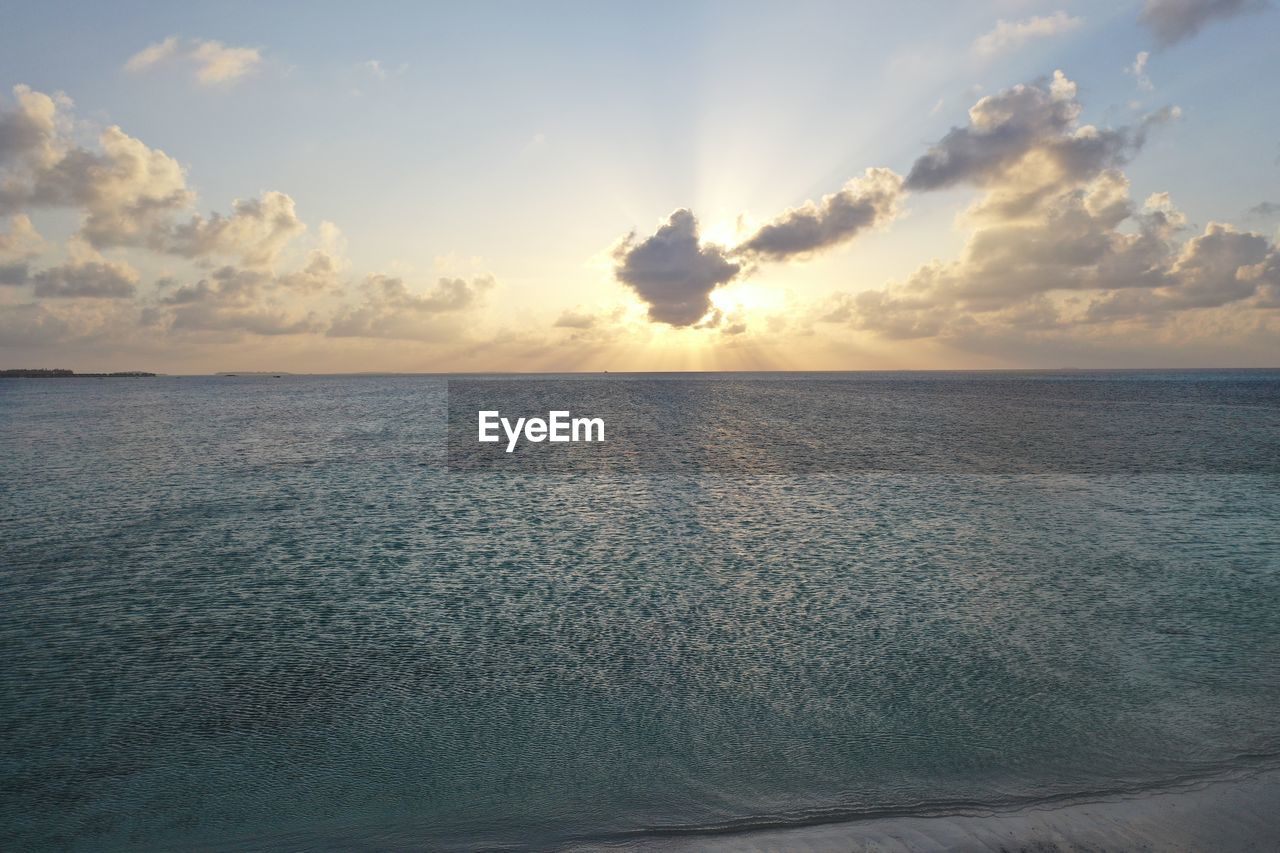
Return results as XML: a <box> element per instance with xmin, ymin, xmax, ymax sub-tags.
<box><xmin>0</xmin><ymin>0</ymin><xmax>1280</xmax><ymax>373</ymax></box>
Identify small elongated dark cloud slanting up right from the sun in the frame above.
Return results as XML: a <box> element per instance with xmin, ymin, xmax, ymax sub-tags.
<box><xmin>733</xmin><ymin>169</ymin><xmax>902</xmax><ymax>261</ymax></box>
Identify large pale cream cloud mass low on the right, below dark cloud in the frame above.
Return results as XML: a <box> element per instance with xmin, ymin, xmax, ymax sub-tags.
<box><xmin>827</xmin><ymin>169</ymin><xmax>1280</xmax><ymax>343</ymax></box>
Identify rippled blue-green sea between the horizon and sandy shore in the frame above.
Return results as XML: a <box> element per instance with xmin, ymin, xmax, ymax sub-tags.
<box><xmin>0</xmin><ymin>371</ymin><xmax>1280</xmax><ymax>850</ymax></box>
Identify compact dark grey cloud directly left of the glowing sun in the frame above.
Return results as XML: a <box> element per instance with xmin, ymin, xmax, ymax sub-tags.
<box><xmin>613</xmin><ymin>209</ymin><xmax>742</xmax><ymax>327</ymax></box>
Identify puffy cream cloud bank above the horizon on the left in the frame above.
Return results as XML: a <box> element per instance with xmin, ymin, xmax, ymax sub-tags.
<box><xmin>0</xmin><ymin>83</ymin><xmax>494</xmax><ymax>346</ymax></box>
